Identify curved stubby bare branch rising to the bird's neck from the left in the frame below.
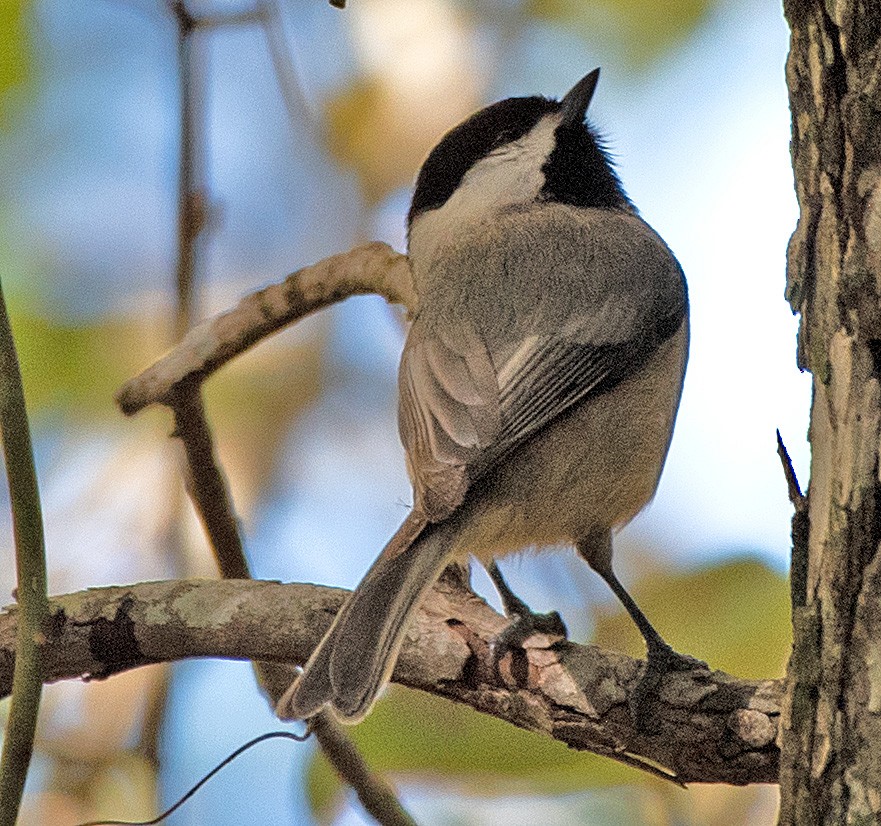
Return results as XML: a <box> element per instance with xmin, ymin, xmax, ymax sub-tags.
<box><xmin>116</xmin><ymin>242</ymin><xmax>416</xmax><ymax>416</ymax></box>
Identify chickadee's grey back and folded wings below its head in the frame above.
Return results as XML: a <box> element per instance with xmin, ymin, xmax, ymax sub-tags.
<box><xmin>399</xmin><ymin>204</ymin><xmax>687</xmax><ymax>521</ymax></box>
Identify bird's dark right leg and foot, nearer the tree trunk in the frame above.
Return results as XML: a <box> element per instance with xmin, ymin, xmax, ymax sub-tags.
<box><xmin>577</xmin><ymin>531</ymin><xmax>708</xmax><ymax>721</ymax></box>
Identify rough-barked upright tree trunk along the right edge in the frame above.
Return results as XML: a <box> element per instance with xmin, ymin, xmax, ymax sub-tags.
<box><xmin>779</xmin><ymin>0</ymin><xmax>881</xmax><ymax>826</ymax></box>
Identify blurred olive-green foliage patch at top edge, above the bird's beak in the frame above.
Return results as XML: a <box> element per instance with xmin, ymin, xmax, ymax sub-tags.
<box><xmin>526</xmin><ymin>0</ymin><xmax>713</xmax><ymax>66</ymax></box>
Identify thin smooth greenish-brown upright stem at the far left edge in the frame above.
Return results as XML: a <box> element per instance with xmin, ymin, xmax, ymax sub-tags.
<box><xmin>0</xmin><ymin>278</ymin><xmax>49</xmax><ymax>826</ymax></box>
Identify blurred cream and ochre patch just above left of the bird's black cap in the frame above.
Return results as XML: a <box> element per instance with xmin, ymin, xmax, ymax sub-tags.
<box><xmin>324</xmin><ymin>0</ymin><xmax>482</xmax><ymax>205</ymax></box>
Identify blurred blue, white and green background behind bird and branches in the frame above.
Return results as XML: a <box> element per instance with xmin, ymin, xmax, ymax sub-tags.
<box><xmin>0</xmin><ymin>0</ymin><xmax>810</xmax><ymax>826</ymax></box>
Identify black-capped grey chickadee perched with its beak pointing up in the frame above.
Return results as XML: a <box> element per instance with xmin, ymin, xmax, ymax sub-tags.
<box><xmin>277</xmin><ymin>69</ymin><xmax>688</xmax><ymax>722</ymax></box>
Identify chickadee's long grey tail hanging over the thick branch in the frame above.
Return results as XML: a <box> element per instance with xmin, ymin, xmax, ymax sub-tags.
<box><xmin>276</xmin><ymin>513</ymin><xmax>456</xmax><ymax>723</ymax></box>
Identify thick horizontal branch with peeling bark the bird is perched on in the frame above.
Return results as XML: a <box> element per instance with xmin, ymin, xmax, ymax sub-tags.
<box><xmin>0</xmin><ymin>579</ymin><xmax>781</xmax><ymax>785</ymax></box>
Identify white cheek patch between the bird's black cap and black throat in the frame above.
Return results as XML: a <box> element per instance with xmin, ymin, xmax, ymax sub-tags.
<box><xmin>409</xmin><ymin>115</ymin><xmax>559</xmax><ymax>261</ymax></box>
